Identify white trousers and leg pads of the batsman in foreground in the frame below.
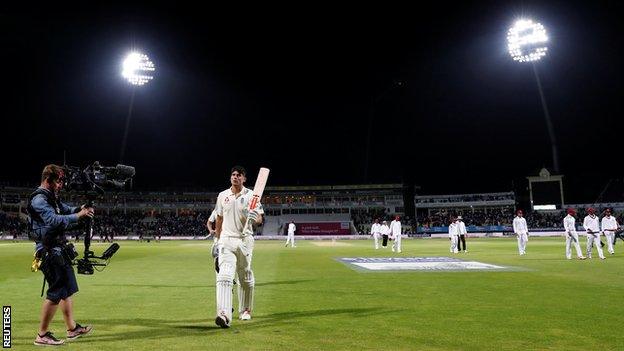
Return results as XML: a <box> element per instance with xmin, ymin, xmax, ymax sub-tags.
<box><xmin>217</xmin><ymin>235</ymin><xmax>255</xmax><ymax>321</ymax></box>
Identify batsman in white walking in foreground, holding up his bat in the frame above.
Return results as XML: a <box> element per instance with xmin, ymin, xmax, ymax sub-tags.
<box><xmin>215</xmin><ymin>166</ymin><xmax>264</xmax><ymax>328</ymax></box>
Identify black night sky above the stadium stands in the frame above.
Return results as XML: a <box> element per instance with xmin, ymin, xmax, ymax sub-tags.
<box><xmin>0</xmin><ymin>1</ymin><xmax>624</xmax><ymax>201</ymax></box>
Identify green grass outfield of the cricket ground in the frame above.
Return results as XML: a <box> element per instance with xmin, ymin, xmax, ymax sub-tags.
<box><xmin>0</xmin><ymin>238</ymin><xmax>624</xmax><ymax>350</ymax></box>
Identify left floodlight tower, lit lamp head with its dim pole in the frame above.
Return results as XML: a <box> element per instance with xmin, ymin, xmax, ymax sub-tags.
<box><xmin>119</xmin><ymin>51</ymin><xmax>156</xmax><ymax>163</ymax></box>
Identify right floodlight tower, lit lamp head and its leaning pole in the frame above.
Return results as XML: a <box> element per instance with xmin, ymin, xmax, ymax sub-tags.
<box><xmin>507</xmin><ymin>19</ymin><xmax>560</xmax><ymax>173</ymax></box>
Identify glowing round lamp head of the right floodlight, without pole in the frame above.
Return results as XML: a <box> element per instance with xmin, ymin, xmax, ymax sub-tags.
<box><xmin>507</xmin><ymin>19</ymin><xmax>548</xmax><ymax>62</ymax></box>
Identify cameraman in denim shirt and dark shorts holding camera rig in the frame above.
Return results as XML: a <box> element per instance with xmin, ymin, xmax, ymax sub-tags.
<box><xmin>28</xmin><ymin>164</ymin><xmax>93</xmax><ymax>346</ymax></box>
